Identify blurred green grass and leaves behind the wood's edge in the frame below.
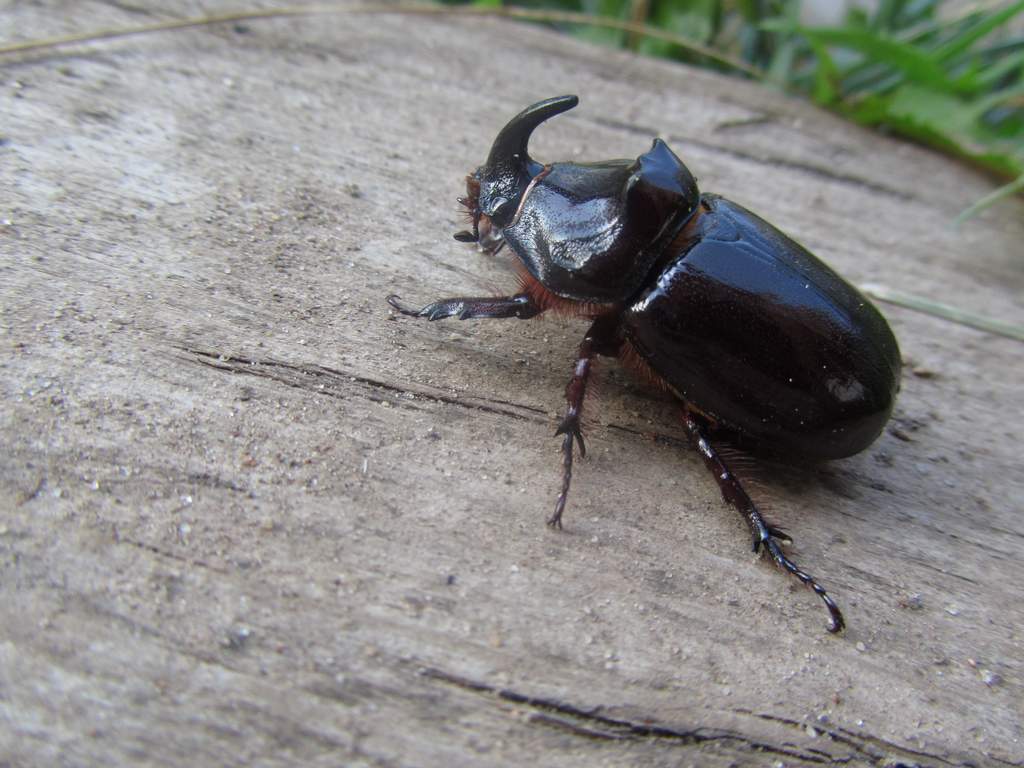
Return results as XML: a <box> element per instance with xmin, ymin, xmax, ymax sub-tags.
<box><xmin>450</xmin><ymin>0</ymin><xmax>1024</xmax><ymax>216</ymax></box>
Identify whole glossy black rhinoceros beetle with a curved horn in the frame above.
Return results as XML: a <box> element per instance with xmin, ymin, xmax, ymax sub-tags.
<box><xmin>388</xmin><ymin>96</ymin><xmax>900</xmax><ymax>632</ymax></box>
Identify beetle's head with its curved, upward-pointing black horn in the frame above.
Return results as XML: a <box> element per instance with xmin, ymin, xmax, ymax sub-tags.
<box><xmin>455</xmin><ymin>96</ymin><xmax>580</xmax><ymax>251</ymax></box>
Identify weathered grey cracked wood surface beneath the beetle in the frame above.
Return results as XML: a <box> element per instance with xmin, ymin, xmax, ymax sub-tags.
<box><xmin>0</xmin><ymin>2</ymin><xmax>1024</xmax><ymax>766</ymax></box>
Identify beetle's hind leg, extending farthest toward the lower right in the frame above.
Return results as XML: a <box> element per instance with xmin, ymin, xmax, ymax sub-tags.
<box><xmin>683</xmin><ymin>412</ymin><xmax>846</xmax><ymax>632</ymax></box>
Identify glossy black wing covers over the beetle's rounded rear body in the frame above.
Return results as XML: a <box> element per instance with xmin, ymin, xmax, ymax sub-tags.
<box><xmin>621</xmin><ymin>195</ymin><xmax>900</xmax><ymax>459</ymax></box>
